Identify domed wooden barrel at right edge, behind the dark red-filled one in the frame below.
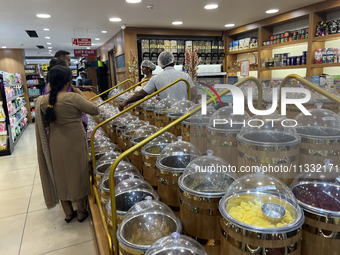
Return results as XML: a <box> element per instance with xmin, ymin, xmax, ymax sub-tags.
<box><xmin>295</xmin><ymin>103</ymin><xmax>340</xmax><ymax>166</ymax></box>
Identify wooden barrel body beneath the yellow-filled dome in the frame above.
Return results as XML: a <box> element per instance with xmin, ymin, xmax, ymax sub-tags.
<box><xmin>220</xmin><ymin>217</ymin><xmax>302</xmax><ymax>255</ymax></box>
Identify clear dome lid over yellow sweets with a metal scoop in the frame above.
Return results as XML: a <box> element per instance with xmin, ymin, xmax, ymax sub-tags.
<box><xmin>219</xmin><ymin>173</ymin><xmax>304</xmax><ymax>234</ymax></box>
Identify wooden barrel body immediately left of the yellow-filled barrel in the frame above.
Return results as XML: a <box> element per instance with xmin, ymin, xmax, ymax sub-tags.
<box><xmin>179</xmin><ymin>189</ymin><xmax>221</xmax><ymax>255</ymax></box>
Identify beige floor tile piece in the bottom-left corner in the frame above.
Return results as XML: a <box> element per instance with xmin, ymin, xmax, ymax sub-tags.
<box><xmin>0</xmin><ymin>214</ymin><xmax>26</xmax><ymax>255</ymax></box>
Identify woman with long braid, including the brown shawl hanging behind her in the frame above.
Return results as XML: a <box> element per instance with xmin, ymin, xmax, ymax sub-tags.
<box><xmin>36</xmin><ymin>66</ymin><xmax>99</xmax><ymax>222</ymax></box>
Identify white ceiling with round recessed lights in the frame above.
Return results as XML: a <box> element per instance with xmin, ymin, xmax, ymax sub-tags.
<box><xmin>0</xmin><ymin>0</ymin><xmax>322</xmax><ymax>56</ymax></box>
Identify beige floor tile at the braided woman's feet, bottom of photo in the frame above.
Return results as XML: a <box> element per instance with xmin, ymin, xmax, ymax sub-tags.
<box><xmin>20</xmin><ymin>206</ymin><xmax>93</xmax><ymax>255</ymax></box>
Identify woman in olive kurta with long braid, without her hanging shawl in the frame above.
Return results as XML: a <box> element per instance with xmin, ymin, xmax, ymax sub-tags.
<box><xmin>40</xmin><ymin>66</ymin><xmax>99</xmax><ymax>222</ymax></box>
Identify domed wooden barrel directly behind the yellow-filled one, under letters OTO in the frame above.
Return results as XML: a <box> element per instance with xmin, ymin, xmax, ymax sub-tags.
<box><xmin>237</xmin><ymin>112</ymin><xmax>301</xmax><ymax>185</ymax></box>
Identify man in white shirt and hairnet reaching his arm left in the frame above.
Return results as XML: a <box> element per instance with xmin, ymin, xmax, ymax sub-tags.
<box><xmin>118</xmin><ymin>51</ymin><xmax>197</xmax><ymax>111</ymax></box>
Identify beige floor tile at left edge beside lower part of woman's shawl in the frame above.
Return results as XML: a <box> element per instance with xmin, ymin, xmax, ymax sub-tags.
<box><xmin>0</xmin><ymin>167</ymin><xmax>36</xmax><ymax>191</ymax></box>
